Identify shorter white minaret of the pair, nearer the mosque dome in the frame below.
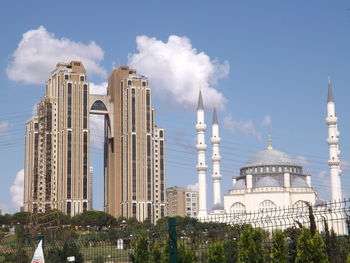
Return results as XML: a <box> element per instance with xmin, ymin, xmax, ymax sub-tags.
<box><xmin>211</xmin><ymin>108</ymin><xmax>222</xmax><ymax>210</ymax></box>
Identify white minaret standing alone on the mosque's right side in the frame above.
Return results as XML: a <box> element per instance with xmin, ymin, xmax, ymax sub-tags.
<box><xmin>326</xmin><ymin>78</ymin><xmax>342</xmax><ymax>201</ymax></box>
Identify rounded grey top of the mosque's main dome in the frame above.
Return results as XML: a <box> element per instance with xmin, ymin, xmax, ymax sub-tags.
<box><xmin>247</xmin><ymin>149</ymin><xmax>296</xmax><ymax>166</ymax></box>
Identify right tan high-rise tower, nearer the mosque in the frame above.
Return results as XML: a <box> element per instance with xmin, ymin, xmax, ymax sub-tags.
<box><xmin>105</xmin><ymin>66</ymin><xmax>166</xmax><ymax>221</ymax></box>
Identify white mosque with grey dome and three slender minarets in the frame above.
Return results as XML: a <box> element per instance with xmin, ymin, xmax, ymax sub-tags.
<box><xmin>196</xmin><ymin>80</ymin><xmax>341</xmax><ymax>218</ymax></box>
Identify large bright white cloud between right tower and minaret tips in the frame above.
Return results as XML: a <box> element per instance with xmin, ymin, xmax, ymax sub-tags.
<box><xmin>128</xmin><ymin>35</ymin><xmax>230</xmax><ymax>108</ymax></box>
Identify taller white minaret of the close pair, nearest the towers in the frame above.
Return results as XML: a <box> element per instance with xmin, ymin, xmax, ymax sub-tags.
<box><xmin>196</xmin><ymin>91</ymin><xmax>208</xmax><ymax>217</ymax></box>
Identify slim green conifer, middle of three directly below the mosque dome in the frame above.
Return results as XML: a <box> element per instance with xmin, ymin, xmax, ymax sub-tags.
<box><xmin>270</xmin><ymin>230</ymin><xmax>288</xmax><ymax>263</ymax></box>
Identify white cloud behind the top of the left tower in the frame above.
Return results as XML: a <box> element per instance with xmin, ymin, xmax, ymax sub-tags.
<box><xmin>6</xmin><ymin>26</ymin><xmax>106</xmax><ymax>84</ymax></box>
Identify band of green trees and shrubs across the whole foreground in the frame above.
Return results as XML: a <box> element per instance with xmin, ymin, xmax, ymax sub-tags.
<box><xmin>0</xmin><ymin>209</ymin><xmax>350</xmax><ymax>263</ymax></box>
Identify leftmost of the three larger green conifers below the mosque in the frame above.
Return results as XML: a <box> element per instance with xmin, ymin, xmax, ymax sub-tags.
<box><xmin>238</xmin><ymin>226</ymin><xmax>265</xmax><ymax>263</ymax></box>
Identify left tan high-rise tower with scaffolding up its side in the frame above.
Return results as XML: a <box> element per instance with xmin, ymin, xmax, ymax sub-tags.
<box><xmin>24</xmin><ymin>61</ymin><xmax>91</xmax><ymax>215</ymax></box>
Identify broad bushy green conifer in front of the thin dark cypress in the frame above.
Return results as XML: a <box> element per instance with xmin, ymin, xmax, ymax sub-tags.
<box><xmin>295</xmin><ymin>228</ymin><xmax>329</xmax><ymax>263</ymax></box>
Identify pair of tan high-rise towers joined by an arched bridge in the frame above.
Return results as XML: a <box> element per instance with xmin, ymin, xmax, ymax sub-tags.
<box><xmin>24</xmin><ymin>61</ymin><xmax>166</xmax><ymax>222</ymax></box>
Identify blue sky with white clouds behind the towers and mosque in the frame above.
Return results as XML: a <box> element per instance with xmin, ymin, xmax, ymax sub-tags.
<box><xmin>0</xmin><ymin>0</ymin><xmax>350</xmax><ymax>213</ymax></box>
